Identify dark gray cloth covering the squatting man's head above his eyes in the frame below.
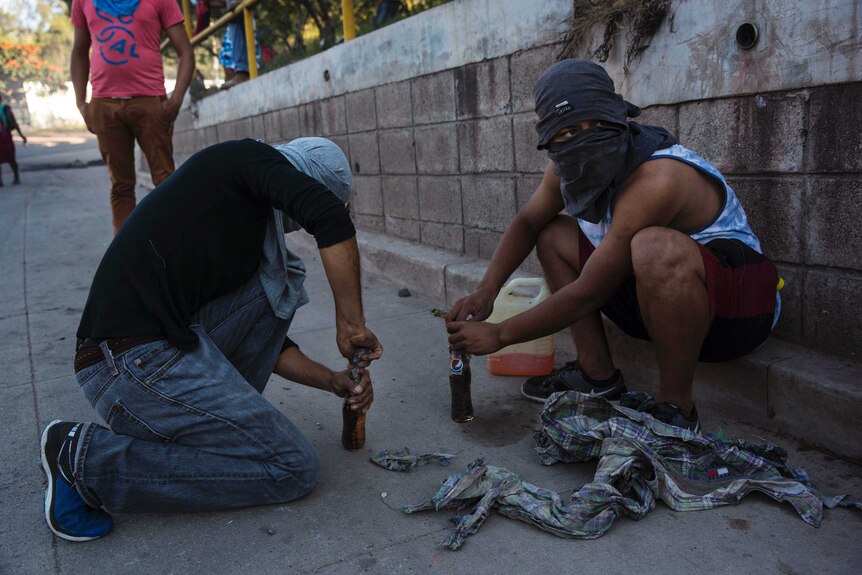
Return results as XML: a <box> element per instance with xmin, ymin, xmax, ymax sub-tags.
<box><xmin>533</xmin><ymin>59</ymin><xmax>641</xmax><ymax>150</ymax></box>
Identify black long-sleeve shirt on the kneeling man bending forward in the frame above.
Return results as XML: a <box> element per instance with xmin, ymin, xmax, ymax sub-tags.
<box><xmin>77</xmin><ymin>140</ymin><xmax>356</xmax><ymax>349</ymax></box>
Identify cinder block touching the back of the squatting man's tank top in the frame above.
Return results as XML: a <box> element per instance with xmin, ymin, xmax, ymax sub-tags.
<box><xmin>729</xmin><ymin>177</ymin><xmax>805</xmax><ymax>263</ymax></box>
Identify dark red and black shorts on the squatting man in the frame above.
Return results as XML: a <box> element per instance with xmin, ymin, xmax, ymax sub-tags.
<box><xmin>578</xmin><ymin>230</ymin><xmax>778</xmax><ymax>361</ymax></box>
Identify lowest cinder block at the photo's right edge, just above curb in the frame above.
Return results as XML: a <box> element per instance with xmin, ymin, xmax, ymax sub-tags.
<box><xmin>802</xmin><ymin>269</ymin><xmax>862</xmax><ymax>360</ymax></box>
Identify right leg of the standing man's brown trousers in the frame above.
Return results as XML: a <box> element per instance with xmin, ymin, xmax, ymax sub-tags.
<box><xmin>130</xmin><ymin>96</ymin><xmax>174</xmax><ymax>186</ymax></box>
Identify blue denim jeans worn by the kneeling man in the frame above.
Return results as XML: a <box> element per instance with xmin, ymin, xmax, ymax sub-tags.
<box><xmin>75</xmin><ymin>274</ymin><xmax>320</xmax><ymax>513</ymax></box>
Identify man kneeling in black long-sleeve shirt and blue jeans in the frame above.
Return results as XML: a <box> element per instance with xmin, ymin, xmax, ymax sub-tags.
<box><xmin>41</xmin><ymin>138</ymin><xmax>382</xmax><ymax>541</ymax></box>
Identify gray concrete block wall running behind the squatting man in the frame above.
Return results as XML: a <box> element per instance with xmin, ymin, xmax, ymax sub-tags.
<box><xmin>167</xmin><ymin>0</ymin><xmax>862</xmax><ymax>359</ymax></box>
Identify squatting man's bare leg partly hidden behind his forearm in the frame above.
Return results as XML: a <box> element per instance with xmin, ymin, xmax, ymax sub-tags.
<box><xmin>536</xmin><ymin>216</ymin><xmax>615</xmax><ymax>380</ymax></box>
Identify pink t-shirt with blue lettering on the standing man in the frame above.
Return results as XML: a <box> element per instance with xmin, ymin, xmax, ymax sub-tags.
<box><xmin>72</xmin><ymin>0</ymin><xmax>183</xmax><ymax>98</ymax></box>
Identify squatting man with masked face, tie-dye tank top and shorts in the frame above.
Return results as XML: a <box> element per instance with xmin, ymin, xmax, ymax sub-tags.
<box><xmin>446</xmin><ymin>59</ymin><xmax>780</xmax><ymax>432</ymax></box>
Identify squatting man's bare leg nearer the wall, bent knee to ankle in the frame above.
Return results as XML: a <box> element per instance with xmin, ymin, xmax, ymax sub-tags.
<box><xmin>631</xmin><ymin>227</ymin><xmax>710</xmax><ymax>414</ymax></box>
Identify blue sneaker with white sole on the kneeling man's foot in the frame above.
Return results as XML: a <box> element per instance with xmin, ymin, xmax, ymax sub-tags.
<box><xmin>42</xmin><ymin>419</ymin><xmax>114</xmax><ymax>541</ymax></box>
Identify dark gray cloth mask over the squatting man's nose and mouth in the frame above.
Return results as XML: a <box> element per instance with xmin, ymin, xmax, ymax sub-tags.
<box><xmin>546</xmin><ymin>124</ymin><xmax>629</xmax><ymax>224</ymax></box>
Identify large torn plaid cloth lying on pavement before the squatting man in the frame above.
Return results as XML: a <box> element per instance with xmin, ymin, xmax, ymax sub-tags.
<box><xmin>396</xmin><ymin>392</ymin><xmax>862</xmax><ymax>549</ymax></box>
